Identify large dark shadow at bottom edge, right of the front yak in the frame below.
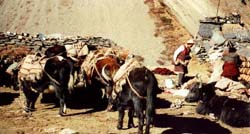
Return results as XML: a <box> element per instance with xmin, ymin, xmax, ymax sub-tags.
<box><xmin>154</xmin><ymin>114</ymin><xmax>231</xmax><ymax>134</ymax></box>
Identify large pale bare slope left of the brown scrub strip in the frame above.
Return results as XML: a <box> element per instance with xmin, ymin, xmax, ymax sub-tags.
<box><xmin>0</xmin><ymin>0</ymin><xmax>163</xmax><ymax>65</ymax></box>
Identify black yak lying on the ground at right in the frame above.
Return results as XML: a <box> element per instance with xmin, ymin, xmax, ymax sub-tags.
<box><xmin>185</xmin><ymin>82</ymin><xmax>250</xmax><ymax>127</ymax></box>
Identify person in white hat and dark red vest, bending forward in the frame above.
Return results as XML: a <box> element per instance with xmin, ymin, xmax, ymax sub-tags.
<box><xmin>173</xmin><ymin>39</ymin><xmax>194</xmax><ymax>87</ymax></box>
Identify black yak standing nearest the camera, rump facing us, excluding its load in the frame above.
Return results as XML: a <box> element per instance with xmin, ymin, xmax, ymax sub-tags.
<box><xmin>105</xmin><ymin>62</ymin><xmax>159</xmax><ymax>134</ymax></box>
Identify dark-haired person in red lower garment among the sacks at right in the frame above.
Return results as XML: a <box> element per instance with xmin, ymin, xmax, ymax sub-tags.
<box><xmin>221</xmin><ymin>47</ymin><xmax>241</xmax><ymax>81</ymax></box>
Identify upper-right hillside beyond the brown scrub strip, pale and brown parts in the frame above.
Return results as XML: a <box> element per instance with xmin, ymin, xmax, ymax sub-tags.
<box><xmin>162</xmin><ymin>0</ymin><xmax>250</xmax><ymax>35</ymax></box>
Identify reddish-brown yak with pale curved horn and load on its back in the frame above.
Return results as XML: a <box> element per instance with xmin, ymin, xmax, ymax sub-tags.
<box><xmin>80</xmin><ymin>48</ymin><xmax>126</xmax><ymax>97</ymax></box>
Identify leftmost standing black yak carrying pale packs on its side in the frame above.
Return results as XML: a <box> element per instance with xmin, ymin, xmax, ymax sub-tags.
<box><xmin>18</xmin><ymin>55</ymin><xmax>73</xmax><ymax>116</ymax></box>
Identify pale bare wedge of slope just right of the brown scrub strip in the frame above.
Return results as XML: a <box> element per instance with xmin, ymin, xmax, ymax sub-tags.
<box><xmin>163</xmin><ymin>0</ymin><xmax>216</xmax><ymax>35</ymax></box>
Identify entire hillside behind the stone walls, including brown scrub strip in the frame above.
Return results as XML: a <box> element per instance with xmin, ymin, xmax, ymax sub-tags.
<box><xmin>0</xmin><ymin>0</ymin><xmax>250</xmax><ymax>65</ymax></box>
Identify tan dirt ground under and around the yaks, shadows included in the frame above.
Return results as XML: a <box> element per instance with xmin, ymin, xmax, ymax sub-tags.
<box><xmin>0</xmin><ymin>61</ymin><xmax>250</xmax><ymax>134</ymax></box>
